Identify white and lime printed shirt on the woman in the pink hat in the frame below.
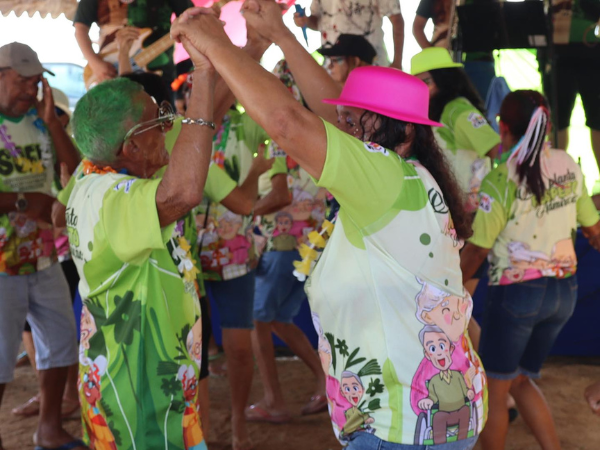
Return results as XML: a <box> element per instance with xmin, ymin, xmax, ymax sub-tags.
<box><xmin>306</xmin><ymin>122</ymin><xmax>487</xmax><ymax>445</ymax></box>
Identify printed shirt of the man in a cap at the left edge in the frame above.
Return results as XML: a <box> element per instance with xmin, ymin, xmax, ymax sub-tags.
<box><xmin>0</xmin><ymin>109</ymin><xmax>57</xmax><ymax>276</ymax></box>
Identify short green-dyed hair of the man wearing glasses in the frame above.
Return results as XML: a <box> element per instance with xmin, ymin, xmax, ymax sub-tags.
<box><xmin>71</xmin><ymin>78</ymin><xmax>144</xmax><ymax>162</ymax></box>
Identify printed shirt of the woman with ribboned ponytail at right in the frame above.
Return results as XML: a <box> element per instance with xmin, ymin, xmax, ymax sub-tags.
<box><xmin>470</xmin><ymin>148</ymin><xmax>599</xmax><ymax>285</ymax></box>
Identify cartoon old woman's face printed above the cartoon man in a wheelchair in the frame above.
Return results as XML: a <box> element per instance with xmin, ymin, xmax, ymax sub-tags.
<box><xmin>415</xmin><ymin>278</ymin><xmax>473</xmax><ymax>342</ymax></box>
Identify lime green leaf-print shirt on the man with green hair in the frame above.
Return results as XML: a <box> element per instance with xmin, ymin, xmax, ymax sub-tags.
<box><xmin>67</xmin><ymin>174</ymin><xmax>203</xmax><ymax>450</ymax></box>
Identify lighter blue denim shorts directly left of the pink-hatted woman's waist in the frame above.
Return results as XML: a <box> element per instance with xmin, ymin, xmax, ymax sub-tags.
<box><xmin>254</xmin><ymin>251</ymin><xmax>306</xmax><ymax>323</ymax></box>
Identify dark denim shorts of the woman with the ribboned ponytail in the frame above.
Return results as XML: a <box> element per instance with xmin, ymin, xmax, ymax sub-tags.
<box><xmin>479</xmin><ymin>276</ymin><xmax>577</xmax><ymax>380</ymax></box>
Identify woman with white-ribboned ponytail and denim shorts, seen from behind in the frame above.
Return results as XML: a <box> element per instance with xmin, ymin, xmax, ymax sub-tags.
<box><xmin>461</xmin><ymin>90</ymin><xmax>600</xmax><ymax>450</ymax></box>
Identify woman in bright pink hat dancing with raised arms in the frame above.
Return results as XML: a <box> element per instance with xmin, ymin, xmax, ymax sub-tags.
<box><xmin>171</xmin><ymin>4</ymin><xmax>487</xmax><ymax>450</ymax></box>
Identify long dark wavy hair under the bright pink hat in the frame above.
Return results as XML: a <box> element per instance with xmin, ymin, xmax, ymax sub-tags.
<box><xmin>360</xmin><ymin>111</ymin><xmax>473</xmax><ymax>239</ymax></box>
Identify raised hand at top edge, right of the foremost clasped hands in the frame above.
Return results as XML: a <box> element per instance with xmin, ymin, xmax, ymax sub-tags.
<box><xmin>242</xmin><ymin>0</ymin><xmax>290</xmax><ymax>44</ymax></box>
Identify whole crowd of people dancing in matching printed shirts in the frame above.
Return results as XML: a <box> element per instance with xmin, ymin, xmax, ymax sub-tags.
<box><xmin>0</xmin><ymin>0</ymin><xmax>600</xmax><ymax>450</ymax></box>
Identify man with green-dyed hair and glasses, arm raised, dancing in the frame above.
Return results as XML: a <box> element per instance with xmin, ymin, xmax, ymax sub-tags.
<box><xmin>67</xmin><ymin>25</ymin><xmax>215</xmax><ymax>450</ymax></box>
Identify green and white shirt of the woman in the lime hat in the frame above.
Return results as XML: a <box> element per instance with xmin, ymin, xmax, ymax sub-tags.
<box><xmin>433</xmin><ymin>97</ymin><xmax>500</xmax><ymax>212</ymax></box>
